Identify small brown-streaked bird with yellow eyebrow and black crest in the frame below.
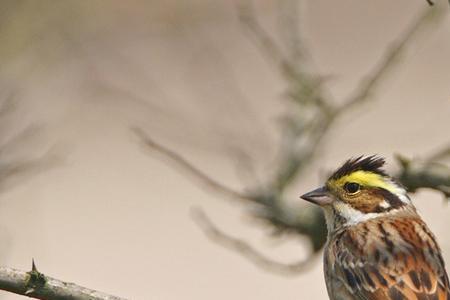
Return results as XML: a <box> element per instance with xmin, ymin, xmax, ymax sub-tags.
<box><xmin>301</xmin><ymin>156</ymin><xmax>450</xmax><ymax>300</ymax></box>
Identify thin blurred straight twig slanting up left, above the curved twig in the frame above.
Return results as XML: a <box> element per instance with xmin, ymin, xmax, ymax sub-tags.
<box><xmin>132</xmin><ymin>128</ymin><xmax>254</xmax><ymax>201</ymax></box>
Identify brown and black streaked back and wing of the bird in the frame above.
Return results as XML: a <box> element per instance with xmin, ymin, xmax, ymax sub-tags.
<box><xmin>327</xmin><ymin>218</ymin><xmax>450</xmax><ymax>300</ymax></box>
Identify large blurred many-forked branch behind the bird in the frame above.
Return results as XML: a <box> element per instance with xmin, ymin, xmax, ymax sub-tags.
<box><xmin>134</xmin><ymin>4</ymin><xmax>450</xmax><ymax>274</ymax></box>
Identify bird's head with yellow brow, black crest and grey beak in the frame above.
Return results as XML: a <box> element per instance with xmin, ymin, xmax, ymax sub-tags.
<box><xmin>301</xmin><ymin>156</ymin><xmax>414</xmax><ymax>229</ymax></box>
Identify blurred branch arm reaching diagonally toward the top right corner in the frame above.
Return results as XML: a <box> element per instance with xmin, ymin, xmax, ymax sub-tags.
<box><xmin>340</xmin><ymin>8</ymin><xmax>443</xmax><ymax>111</ymax></box>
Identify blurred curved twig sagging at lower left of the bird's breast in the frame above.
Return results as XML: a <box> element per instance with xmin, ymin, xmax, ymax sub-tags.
<box><xmin>192</xmin><ymin>208</ymin><xmax>318</xmax><ymax>275</ymax></box>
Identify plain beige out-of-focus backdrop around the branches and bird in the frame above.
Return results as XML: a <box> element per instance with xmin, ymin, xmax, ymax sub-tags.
<box><xmin>0</xmin><ymin>0</ymin><xmax>450</xmax><ymax>300</ymax></box>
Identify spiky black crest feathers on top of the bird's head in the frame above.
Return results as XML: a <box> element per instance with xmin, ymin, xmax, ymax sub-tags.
<box><xmin>330</xmin><ymin>155</ymin><xmax>388</xmax><ymax>179</ymax></box>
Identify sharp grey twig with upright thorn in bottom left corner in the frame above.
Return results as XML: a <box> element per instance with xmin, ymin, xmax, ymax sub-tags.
<box><xmin>0</xmin><ymin>260</ymin><xmax>126</xmax><ymax>300</ymax></box>
